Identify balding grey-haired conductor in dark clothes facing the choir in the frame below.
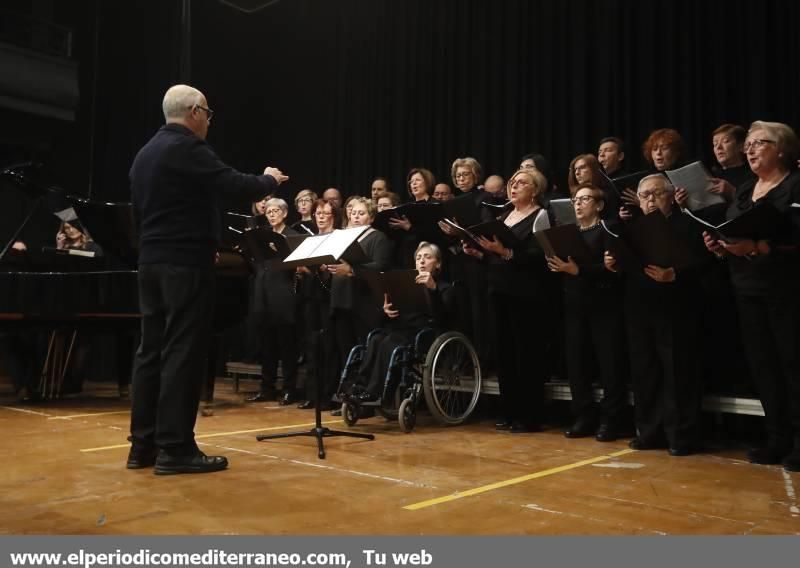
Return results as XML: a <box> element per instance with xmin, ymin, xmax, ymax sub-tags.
<box><xmin>127</xmin><ymin>85</ymin><xmax>288</xmax><ymax>475</ymax></box>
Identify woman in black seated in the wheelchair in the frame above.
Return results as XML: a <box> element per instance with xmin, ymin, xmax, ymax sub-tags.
<box><xmin>345</xmin><ymin>241</ymin><xmax>453</xmax><ymax>403</ymax></box>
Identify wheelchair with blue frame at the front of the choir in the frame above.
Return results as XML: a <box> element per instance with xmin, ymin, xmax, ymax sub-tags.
<box><xmin>337</xmin><ymin>328</ymin><xmax>481</xmax><ymax>433</ymax></box>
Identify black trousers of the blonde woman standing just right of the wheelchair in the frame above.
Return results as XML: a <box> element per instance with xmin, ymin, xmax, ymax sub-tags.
<box><xmin>490</xmin><ymin>293</ymin><xmax>549</xmax><ymax>427</ymax></box>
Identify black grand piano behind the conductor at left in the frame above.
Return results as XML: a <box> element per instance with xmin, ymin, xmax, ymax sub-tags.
<box><xmin>0</xmin><ymin>170</ymin><xmax>250</xmax><ymax>408</ymax></box>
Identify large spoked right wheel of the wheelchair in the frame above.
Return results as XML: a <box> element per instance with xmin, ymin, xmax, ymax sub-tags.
<box><xmin>422</xmin><ymin>331</ymin><xmax>481</xmax><ymax>424</ymax></box>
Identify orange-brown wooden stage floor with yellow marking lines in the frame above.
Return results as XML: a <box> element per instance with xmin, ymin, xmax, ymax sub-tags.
<box><xmin>0</xmin><ymin>381</ymin><xmax>800</xmax><ymax>535</ymax></box>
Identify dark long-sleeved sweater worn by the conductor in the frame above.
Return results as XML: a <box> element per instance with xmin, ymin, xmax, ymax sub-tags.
<box><xmin>129</xmin><ymin>124</ymin><xmax>278</xmax><ymax>267</ymax></box>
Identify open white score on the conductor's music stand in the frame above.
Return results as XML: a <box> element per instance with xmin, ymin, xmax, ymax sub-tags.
<box><xmin>281</xmin><ymin>227</ymin><xmax>369</xmax><ymax>270</ymax></box>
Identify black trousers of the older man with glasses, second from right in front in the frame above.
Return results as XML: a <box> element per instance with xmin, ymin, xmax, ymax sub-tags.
<box><xmin>625</xmin><ymin>301</ymin><xmax>702</xmax><ymax>446</ymax></box>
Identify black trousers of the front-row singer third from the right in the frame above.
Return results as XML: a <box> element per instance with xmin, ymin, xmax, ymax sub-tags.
<box><xmin>564</xmin><ymin>296</ymin><xmax>628</xmax><ymax>424</ymax></box>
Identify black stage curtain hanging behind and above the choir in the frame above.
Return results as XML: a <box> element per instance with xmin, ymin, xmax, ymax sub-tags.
<box><xmin>67</xmin><ymin>0</ymin><xmax>800</xmax><ymax>200</ymax></box>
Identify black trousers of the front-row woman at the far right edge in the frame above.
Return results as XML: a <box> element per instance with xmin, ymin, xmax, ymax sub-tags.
<box><xmin>737</xmin><ymin>296</ymin><xmax>800</xmax><ymax>449</ymax></box>
